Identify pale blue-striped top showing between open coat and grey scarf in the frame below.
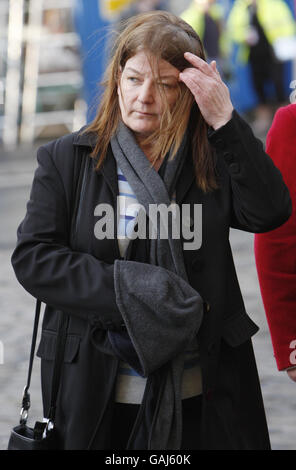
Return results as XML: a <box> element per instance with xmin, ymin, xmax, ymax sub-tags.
<box><xmin>115</xmin><ymin>165</ymin><xmax>202</xmax><ymax>404</ymax></box>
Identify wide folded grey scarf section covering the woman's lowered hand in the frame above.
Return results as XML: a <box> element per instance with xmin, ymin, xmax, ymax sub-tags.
<box><xmin>108</xmin><ymin>260</ymin><xmax>203</xmax><ymax>377</ymax></box>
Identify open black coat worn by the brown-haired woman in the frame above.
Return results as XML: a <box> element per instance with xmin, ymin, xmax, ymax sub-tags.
<box><xmin>12</xmin><ymin>112</ymin><xmax>291</xmax><ymax>449</ymax></box>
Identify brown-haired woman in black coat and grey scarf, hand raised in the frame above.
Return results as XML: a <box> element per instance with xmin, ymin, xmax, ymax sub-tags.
<box><xmin>12</xmin><ymin>12</ymin><xmax>291</xmax><ymax>449</ymax></box>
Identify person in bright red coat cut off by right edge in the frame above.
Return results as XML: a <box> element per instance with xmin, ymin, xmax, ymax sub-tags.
<box><xmin>254</xmin><ymin>104</ymin><xmax>296</xmax><ymax>382</ymax></box>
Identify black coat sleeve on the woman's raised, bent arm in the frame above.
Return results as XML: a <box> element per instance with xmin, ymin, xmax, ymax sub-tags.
<box><xmin>209</xmin><ymin>111</ymin><xmax>292</xmax><ymax>233</ymax></box>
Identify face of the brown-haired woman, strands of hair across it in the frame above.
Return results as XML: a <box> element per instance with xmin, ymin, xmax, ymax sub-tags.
<box><xmin>117</xmin><ymin>51</ymin><xmax>180</xmax><ymax>138</ymax></box>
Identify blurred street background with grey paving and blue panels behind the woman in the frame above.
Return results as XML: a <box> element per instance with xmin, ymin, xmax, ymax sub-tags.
<box><xmin>0</xmin><ymin>0</ymin><xmax>296</xmax><ymax>450</ymax></box>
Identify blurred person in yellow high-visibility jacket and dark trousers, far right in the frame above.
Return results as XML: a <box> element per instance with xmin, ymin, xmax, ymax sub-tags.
<box><xmin>227</xmin><ymin>0</ymin><xmax>296</xmax><ymax>132</ymax></box>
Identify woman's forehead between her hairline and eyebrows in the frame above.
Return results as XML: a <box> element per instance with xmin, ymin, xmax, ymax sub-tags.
<box><xmin>124</xmin><ymin>51</ymin><xmax>180</xmax><ymax>78</ymax></box>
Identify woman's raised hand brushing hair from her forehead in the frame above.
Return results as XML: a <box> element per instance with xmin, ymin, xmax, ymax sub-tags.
<box><xmin>179</xmin><ymin>52</ymin><xmax>233</xmax><ymax>129</ymax></box>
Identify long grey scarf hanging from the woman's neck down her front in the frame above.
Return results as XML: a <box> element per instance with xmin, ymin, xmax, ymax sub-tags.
<box><xmin>111</xmin><ymin>122</ymin><xmax>203</xmax><ymax>450</ymax></box>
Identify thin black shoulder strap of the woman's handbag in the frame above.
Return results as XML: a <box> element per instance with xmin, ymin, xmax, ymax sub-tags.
<box><xmin>20</xmin><ymin>150</ymin><xmax>89</xmax><ymax>425</ymax></box>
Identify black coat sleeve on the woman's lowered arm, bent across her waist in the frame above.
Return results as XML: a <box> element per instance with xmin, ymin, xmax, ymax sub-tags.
<box><xmin>11</xmin><ymin>147</ymin><xmax>123</xmax><ymax>329</ymax></box>
